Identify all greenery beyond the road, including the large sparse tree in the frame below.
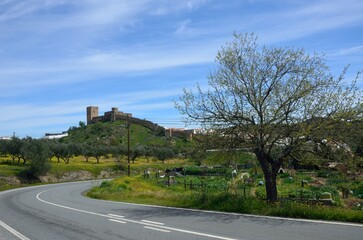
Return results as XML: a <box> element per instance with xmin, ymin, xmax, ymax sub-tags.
<box><xmin>0</xmin><ymin>33</ymin><xmax>363</xmax><ymax>223</ymax></box>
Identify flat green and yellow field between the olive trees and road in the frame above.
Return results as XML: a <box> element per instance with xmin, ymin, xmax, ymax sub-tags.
<box><xmin>0</xmin><ymin>157</ymin><xmax>363</xmax><ymax>223</ymax></box>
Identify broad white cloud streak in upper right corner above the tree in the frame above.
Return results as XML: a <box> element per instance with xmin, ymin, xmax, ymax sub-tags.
<box><xmin>250</xmin><ymin>0</ymin><xmax>363</xmax><ymax>43</ymax></box>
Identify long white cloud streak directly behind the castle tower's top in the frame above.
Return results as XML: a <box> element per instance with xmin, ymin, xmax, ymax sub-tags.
<box><xmin>0</xmin><ymin>86</ymin><xmax>181</xmax><ymax>125</ymax></box>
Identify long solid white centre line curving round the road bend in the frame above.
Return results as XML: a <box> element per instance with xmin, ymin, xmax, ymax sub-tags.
<box><xmin>36</xmin><ymin>189</ymin><xmax>239</xmax><ymax>240</ymax></box>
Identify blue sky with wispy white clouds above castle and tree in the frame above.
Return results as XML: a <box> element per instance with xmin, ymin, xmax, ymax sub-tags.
<box><xmin>0</xmin><ymin>0</ymin><xmax>363</xmax><ymax>137</ymax></box>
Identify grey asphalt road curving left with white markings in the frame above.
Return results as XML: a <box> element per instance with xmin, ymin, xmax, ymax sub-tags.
<box><xmin>0</xmin><ymin>181</ymin><xmax>363</xmax><ymax>240</ymax></box>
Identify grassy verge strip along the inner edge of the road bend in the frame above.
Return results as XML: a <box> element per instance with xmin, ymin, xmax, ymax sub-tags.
<box><xmin>87</xmin><ymin>176</ymin><xmax>363</xmax><ymax>223</ymax></box>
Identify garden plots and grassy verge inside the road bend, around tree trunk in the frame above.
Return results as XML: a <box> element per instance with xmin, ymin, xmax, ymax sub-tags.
<box><xmin>87</xmin><ymin>159</ymin><xmax>363</xmax><ymax>223</ymax></box>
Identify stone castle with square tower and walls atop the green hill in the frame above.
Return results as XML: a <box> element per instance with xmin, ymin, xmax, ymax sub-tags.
<box><xmin>87</xmin><ymin>106</ymin><xmax>194</xmax><ymax>140</ymax></box>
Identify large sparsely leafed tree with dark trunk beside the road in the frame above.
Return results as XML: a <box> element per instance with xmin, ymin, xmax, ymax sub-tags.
<box><xmin>176</xmin><ymin>33</ymin><xmax>361</xmax><ymax>201</ymax></box>
